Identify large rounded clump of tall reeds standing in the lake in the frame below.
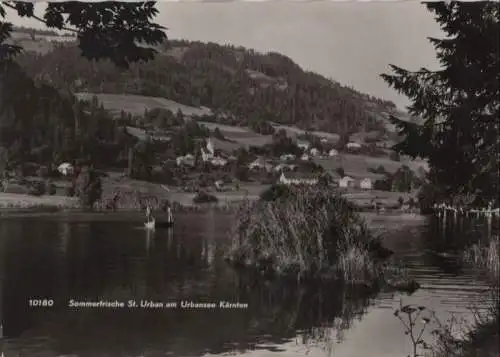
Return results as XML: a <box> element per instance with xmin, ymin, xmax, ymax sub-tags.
<box><xmin>228</xmin><ymin>187</ymin><xmax>398</xmax><ymax>285</ymax></box>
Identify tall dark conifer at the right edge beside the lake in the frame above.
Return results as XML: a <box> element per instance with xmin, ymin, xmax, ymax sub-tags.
<box><xmin>381</xmin><ymin>2</ymin><xmax>500</xmax><ymax>203</ymax></box>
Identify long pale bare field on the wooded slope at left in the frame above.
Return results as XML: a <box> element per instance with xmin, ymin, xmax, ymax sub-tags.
<box><xmin>75</xmin><ymin>92</ymin><xmax>212</xmax><ymax>116</ymax></box>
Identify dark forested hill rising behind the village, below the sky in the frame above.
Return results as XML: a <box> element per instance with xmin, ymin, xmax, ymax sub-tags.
<box><xmin>18</xmin><ymin>40</ymin><xmax>396</xmax><ymax>134</ymax></box>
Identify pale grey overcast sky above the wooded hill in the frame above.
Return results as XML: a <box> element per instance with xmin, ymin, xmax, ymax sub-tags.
<box><xmin>7</xmin><ymin>0</ymin><xmax>443</xmax><ymax>109</ymax></box>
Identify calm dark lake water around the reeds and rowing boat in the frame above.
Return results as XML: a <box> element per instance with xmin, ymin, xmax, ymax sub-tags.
<box><xmin>0</xmin><ymin>213</ymin><xmax>492</xmax><ymax>357</ymax></box>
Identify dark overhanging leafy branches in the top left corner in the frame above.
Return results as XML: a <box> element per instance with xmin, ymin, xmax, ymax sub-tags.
<box><xmin>0</xmin><ymin>1</ymin><xmax>166</xmax><ymax>68</ymax></box>
